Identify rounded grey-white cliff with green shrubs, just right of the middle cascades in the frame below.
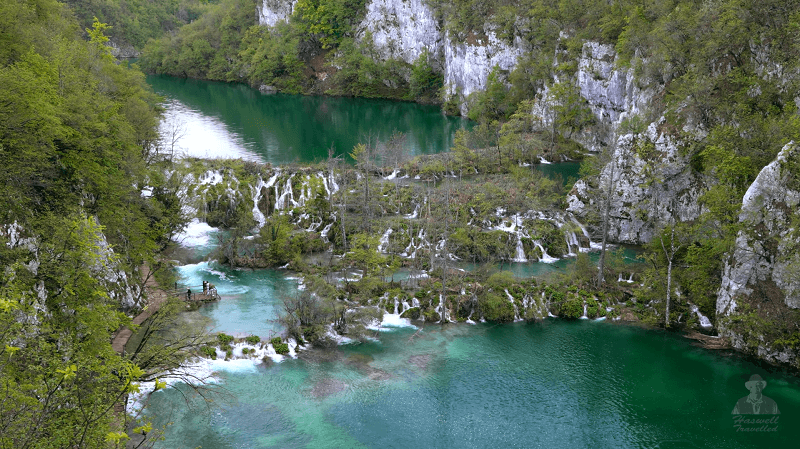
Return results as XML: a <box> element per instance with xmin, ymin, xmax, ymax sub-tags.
<box><xmin>567</xmin><ymin>123</ymin><xmax>704</xmax><ymax>244</ymax></box>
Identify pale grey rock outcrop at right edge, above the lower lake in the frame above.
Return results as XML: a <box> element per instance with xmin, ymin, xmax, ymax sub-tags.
<box><xmin>717</xmin><ymin>142</ymin><xmax>800</xmax><ymax>363</ymax></box>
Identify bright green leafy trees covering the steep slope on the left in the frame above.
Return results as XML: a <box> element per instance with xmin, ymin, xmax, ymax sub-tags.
<box><xmin>0</xmin><ymin>0</ymin><xmax>192</xmax><ymax>448</ymax></box>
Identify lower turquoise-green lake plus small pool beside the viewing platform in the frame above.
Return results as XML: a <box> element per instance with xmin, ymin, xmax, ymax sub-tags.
<box><xmin>153</xmin><ymin>263</ymin><xmax>800</xmax><ymax>449</ymax></box>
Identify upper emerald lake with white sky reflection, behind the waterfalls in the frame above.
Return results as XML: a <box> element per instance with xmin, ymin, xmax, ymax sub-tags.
<box><xmin>147</xmin><ymin>76</ymin><xmax>468</xmax><ymax>164</ymax></box>
